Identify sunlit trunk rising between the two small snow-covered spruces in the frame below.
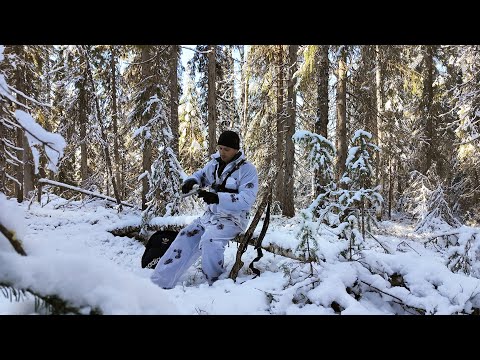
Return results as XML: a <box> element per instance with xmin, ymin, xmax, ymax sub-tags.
<box><xmin>336</xmin><ymin>48</ymin><xmax>347</xmax><ymax>181</ymax></box>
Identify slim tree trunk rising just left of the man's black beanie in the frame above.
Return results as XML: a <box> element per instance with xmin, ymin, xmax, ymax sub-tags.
<box><xmin>207</xmin><ymin>45</ymin><xmax>217</xmax><ymax>154</ymax></box>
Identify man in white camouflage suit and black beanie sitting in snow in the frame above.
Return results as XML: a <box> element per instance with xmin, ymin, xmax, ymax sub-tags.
<box><xmin>151</xmin><ymin>131</ymin><xmax>258</xmax><ymax>289</ymax></box>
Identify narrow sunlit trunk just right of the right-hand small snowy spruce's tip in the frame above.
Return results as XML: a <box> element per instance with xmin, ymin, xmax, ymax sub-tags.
<box><xmin>373</xmin><ymin>45</ymin><xmax>385</xmax><ymax>220</ymax></box>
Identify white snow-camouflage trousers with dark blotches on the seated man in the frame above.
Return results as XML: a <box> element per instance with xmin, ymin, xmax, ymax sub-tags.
<box><xmin>151</xmin><ymin>218</ymin><xmax>242</xmax><ymax>289</ymax></box>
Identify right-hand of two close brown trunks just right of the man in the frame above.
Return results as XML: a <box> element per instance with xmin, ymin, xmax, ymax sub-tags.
<box><xmin>282</xmin><ymin>45</ymin><xmax>298</xmax><ymax>217</ymax></box>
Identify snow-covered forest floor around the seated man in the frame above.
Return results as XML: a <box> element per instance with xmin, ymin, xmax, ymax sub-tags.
<box><xmin>0</xmin><ymin>195</ymin><xmax>480</xmax><ymax>315</ymax></box>
